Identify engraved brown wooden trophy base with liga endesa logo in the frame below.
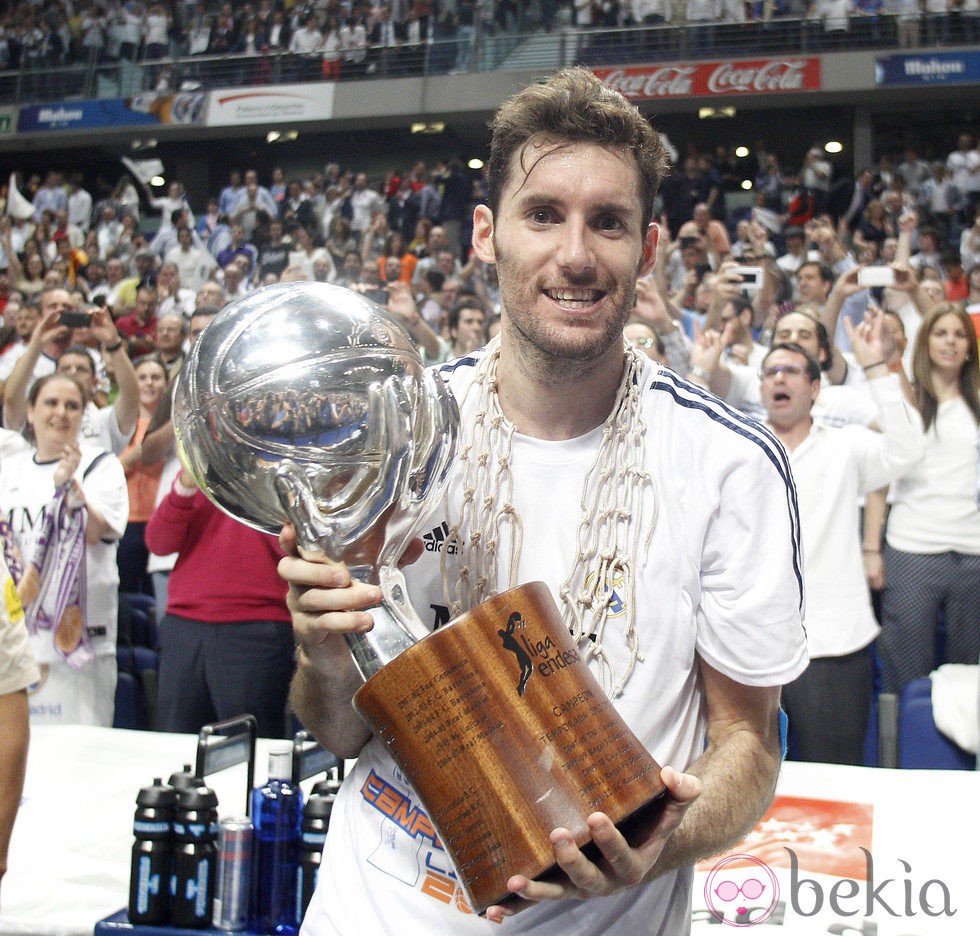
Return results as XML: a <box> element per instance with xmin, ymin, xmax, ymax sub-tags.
<box><xmin>354</xmin><ymin>582</ymin><xmax>666</xmax><ymax>913</ymax></box>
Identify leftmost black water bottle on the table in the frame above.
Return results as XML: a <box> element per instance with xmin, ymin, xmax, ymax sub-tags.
<box><xmin>129</xmin><ymin>777</ymin><xmax>177</xmax><ymax>926</ymax></box>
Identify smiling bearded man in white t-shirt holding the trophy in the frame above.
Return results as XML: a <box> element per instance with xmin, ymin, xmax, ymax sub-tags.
<box><xmin>280</xmin><ymin>69</ymin><xmax>807</xmax><ymax>936</ymax></box>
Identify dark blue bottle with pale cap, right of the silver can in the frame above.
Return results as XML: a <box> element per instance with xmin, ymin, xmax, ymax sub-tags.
<box><xmin>252</xmin><ymin>745</ymin><xmax>303</xmax><ymax>936</ymax></box>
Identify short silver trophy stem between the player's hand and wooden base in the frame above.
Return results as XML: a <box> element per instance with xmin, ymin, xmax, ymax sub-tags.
<box><xmin>344</xmin><ymin>566</ymin><xmax>428</xmax><ymax>682</ymax></box>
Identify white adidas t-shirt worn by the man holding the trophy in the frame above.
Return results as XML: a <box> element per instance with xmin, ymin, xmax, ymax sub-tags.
<box><xmin>302</xmin><ymin>352</ymin><xmax>806</xmax><ymax>936</ymax></box>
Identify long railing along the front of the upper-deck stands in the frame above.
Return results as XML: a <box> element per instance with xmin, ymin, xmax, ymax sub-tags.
<box><xmin>0</xmin><ymin>14</ymin><xmax>980</xmax><ymax>105</ymax></box>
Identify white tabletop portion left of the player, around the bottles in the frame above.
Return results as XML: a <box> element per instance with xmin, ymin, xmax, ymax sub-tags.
<box><xmin>0</xmin><ymin>725</ymin><xmax>280</xmax><ymax>936</ymax></box>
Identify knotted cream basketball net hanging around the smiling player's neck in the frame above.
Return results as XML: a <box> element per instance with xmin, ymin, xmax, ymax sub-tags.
<box><xmin>441</xmin><ymin>336</ymin><xmax>658</xmax><ymax>696</ymax></box>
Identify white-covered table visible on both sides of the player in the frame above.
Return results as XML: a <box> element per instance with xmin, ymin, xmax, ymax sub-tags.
<box><xmin>0</xmin><ymin>726</ymin><xmax>980</xmax><ymax>936</ymax></box>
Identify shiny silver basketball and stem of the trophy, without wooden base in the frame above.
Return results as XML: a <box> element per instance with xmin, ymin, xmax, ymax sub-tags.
<box><xmin>173</xmin><ymin>282</ymin><xmax>459</xmax><ymax>679</ymax></box>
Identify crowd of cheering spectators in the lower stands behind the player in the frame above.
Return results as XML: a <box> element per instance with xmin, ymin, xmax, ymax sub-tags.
<box><xmin>0</xmin><ymin>124</ymin><xmax>980</xmax><ymax>762</ymax></box>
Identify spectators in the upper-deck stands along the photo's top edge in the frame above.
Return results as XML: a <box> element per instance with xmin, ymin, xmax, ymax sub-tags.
<box><xmin>0</xmin><ymin>0</ymin><xmax>980</xmax><ymax>81</ymax></box>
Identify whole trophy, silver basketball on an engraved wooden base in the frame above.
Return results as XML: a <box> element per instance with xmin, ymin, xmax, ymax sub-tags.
<box><xmin>174</xmin><ymin>283</ymin><xmax>666</xmax><ymax>913</ymax></box>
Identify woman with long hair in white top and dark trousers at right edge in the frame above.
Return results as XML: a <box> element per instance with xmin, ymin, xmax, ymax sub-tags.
<box><xmin>880</xmin><ymin>303</ymin><xmax>980</xmax><ymax>692</ymax></box>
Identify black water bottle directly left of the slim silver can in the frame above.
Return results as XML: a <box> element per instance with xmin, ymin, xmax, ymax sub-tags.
<box><xmin>170</xmin><ymin>781</ymin><xmax>218</xmax><ymax>929</ymax></box>
